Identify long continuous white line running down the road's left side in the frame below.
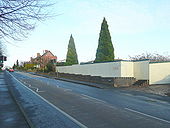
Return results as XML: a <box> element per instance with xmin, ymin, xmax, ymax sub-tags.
<box><xmin>9</xmin><ymin>73</ymin><xmax>87</xmax><ymax>128</ymax></box>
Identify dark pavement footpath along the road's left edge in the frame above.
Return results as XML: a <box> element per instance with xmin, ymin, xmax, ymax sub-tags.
<box><xmin>0</xmin><ymin>72</ymin><xmax>30</xmax><ymax>128</ymax></box>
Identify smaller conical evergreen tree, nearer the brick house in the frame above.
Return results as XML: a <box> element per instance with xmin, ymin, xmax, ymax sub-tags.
<box><xmin>66</xmin><ymin>35</ymin><xmax>78</xmax><ymax>65</ymax></box>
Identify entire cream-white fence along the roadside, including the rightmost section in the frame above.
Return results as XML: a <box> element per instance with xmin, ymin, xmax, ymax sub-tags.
<box><xmin>56</xmin><ymin>60</ymin><xmax>170</xmax><ymax>84</ymax></box>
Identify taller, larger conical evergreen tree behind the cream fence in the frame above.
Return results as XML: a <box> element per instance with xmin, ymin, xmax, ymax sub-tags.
<box><xmin>95</xmin><ymin>18</ymin><xmax>114</xmax><ymax>62</ymax></box>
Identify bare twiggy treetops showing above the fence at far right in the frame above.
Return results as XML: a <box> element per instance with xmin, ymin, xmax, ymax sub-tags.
<box><xmin>129</xmin><ymin>53</ymin><xmax>170</xmax><ymax>62</ymax></box>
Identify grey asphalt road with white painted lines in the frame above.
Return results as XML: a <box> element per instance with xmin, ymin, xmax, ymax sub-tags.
<box><xmin>3</xmin><ymin>72</ymin><xmax>170</xmax><ymax>128</ymax></box>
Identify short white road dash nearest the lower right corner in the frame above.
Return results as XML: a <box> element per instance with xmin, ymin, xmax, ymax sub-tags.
<box><xmin>125</xmin><ymin>108</ymin><xmax>170</xmax><ymax>124</ymax></box>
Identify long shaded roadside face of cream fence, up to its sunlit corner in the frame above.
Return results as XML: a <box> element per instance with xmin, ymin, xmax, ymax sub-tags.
<box><xmin>56</xmin><ymin>62</ymin><xmax>121</xmax><ymax>77</ymax></box>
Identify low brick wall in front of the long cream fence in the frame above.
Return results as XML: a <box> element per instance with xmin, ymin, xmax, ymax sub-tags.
<box><xmin>58</xmin><ymin>73</ymin><xmax>136</xmax><ymax>87</ymax></box>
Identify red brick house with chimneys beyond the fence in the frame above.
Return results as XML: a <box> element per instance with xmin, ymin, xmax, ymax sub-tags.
<box><xmin>30</xmin><ymin>50</ymin><xmax>57</xmax><ymax>68</ymax></box>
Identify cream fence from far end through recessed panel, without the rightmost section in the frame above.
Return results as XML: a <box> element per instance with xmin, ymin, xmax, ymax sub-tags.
<box><xmin>56</xmin><ymin>61</ymin><xmax>149</xmax><ymax>80</ymax></box>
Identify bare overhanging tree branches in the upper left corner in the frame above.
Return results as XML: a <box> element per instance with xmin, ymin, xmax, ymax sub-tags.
<box><xmin>0</xmin><ymin>0</ymin><xmax>52</xmax><ymax>40</ymax></box>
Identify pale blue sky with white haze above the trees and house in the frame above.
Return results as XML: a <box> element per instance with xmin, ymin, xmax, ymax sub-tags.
<box><xmin>3</xmin><ymin>0</ymin><xmax>170</xmax><ymax>66</ymax></box>
